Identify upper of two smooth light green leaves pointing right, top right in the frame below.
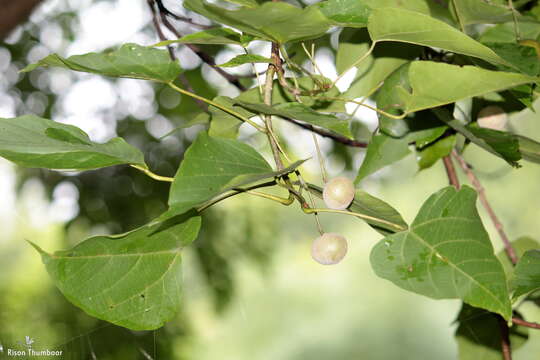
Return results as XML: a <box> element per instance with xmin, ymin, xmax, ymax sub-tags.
<box><xmin>368</xmin><ymin>8</ymin><xmax>507</xmax><ymax>65</ymax></box>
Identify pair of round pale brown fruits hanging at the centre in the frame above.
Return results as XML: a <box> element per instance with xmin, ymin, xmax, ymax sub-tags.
<box><xmin>311</xmin><ymin>177</ymin><xmax>355</xmax><ymax>265</ymax></box>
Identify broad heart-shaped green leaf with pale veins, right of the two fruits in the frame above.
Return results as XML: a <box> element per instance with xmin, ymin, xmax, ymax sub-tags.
<box><xmin>370</xmin><ymin>186</ymin><xmax>512</xmax><ymax>320</ymax></box>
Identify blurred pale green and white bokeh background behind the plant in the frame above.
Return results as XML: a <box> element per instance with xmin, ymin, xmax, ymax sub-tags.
<box><xmin>0</xmin><ymin>0</ymin><xmax>540</xmax><ymax>360</ymax></box>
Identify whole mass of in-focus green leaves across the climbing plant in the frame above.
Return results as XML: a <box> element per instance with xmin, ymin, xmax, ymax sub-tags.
<box><xmin>0</xmin><ymin>0</ymin><xmax>540</xmax><ymax>358</ymax></box>
